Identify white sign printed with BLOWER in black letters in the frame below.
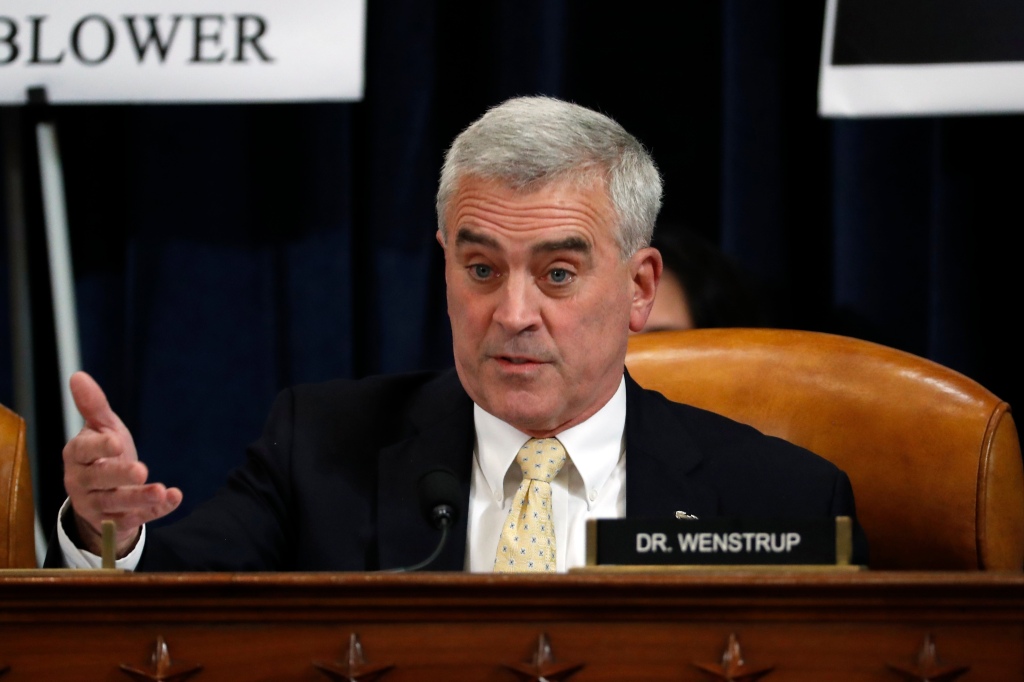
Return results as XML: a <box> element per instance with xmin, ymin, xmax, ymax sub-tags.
<box><xmin>0</xmin><ymin>0</ymin><xmax>366</xmax><ymax>104</ymax></box>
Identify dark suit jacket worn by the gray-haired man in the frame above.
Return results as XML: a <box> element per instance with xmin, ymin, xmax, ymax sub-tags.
<box><xmin>46</xmin><ymin>371</ymin><xmax>866</xmax><ymax>570</ymax></box>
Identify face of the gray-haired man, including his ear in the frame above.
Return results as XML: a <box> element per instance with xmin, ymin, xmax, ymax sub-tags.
<box><xmin>438</xmin><ymin>177</ymin><xmax>662</xmax><ymax>436</ymax></box>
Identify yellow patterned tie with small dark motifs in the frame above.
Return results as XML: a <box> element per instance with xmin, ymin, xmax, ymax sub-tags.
<box><xmin>495</xmin><ymin>438</ymin><xmax>565</xmax><ymax>573</ymax></box>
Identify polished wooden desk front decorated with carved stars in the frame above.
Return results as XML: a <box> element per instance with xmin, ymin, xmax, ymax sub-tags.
<box><xmin>0</xmin><ymin>571</ymin><xmax>1024</xmax><ymax>682</ymax></box>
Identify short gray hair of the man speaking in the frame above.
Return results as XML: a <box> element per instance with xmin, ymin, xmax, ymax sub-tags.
<box><xmin>437</xmin><ymin>97</ymin><xmax>662</xmax><ymax>258</ymax></box>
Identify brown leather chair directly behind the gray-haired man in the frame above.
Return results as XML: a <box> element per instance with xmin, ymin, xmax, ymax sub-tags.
<box><xmin>626</xmin><ymin>329</ymin><xmax>1024</xmax><ymax>570</ymax></box>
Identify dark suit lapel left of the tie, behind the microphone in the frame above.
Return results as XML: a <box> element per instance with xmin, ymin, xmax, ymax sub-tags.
<box><xmin>377</xmin><ymin>372</ymin><xmax>474</xmax><ymax>570</ymax></box>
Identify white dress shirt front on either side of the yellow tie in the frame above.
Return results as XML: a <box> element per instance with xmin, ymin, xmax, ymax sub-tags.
<box><xmin>466</xmin><ymin>377</ymin><xmax>626</xmax><ymax>572</ymax></box>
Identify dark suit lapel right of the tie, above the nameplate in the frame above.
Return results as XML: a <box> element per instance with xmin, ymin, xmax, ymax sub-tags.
<box><xmin>626</xmin><ymin>374</ymin><xmax>719</xmax><ymax>518</ymax></box>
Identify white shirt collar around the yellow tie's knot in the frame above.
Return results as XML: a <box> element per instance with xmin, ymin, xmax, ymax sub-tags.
<box><xmin>473</xmin><ymin>376</ymin><xmax>626</xmax><ymax>501</ymax></box>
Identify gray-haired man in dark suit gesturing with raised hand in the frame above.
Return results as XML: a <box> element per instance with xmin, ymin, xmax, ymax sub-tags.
<box><xmin>50</xmin><ymin>97</ymin><xmax>855</xmax><ymax>570</ymax></box>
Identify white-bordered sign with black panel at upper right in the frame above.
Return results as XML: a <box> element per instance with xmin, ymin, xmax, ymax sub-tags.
<box><xmin>818</xmin><ymin>0</ymin><xmax>1024</xmax><ymax>117</ymax></box>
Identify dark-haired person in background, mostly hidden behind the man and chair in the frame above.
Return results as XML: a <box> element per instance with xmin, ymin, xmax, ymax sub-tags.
<box><xmin>643</xmin><ymin>223</ymin><xmax>770</xmax><ymax>332</ymax></box>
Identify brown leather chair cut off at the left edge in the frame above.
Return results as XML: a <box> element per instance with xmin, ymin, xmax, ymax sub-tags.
<box><xmin>0</xmin><ymin>406</ymin><xmax>36</xmax><ymax>568</ymax></box>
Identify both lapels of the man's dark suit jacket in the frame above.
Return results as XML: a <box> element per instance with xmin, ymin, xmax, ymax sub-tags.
<box><xmin>377</xmin><ymin>372</ymin><xmax>719</xmax><ymax>570</ymax></box>
